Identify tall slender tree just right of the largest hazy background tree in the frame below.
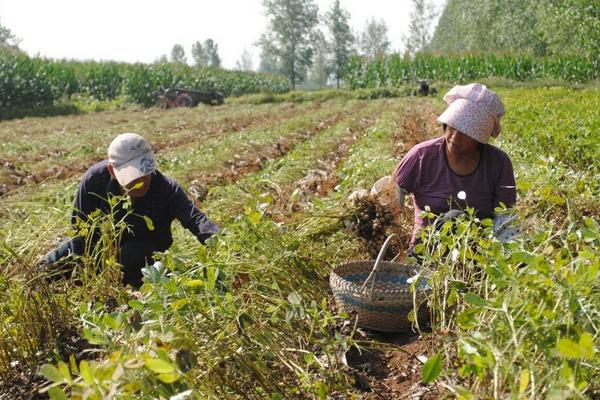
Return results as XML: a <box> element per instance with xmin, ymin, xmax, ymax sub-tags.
<box><xmin>325</xmin><ymin>0</ymin><xmax>354</xmax><ymax>89</ymax></box>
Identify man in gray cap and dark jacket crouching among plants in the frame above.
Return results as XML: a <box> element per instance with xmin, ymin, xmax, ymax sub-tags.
<box><xmin>41</xmin><ymin>133</ymin><xmax>218</xmax><ymax>287</ymax></box>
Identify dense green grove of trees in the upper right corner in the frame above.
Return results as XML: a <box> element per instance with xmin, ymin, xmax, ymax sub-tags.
<box><xmin>426</xmin><ymin>0</ymin><xmax>600</xmax><ymax>60</ymax></box>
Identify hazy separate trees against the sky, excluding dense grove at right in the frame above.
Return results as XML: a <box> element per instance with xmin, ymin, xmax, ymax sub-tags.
<box><xmin>162</xmin><ymin>0</ymin><xmax>436</xmax><ymax>88</ymax></box>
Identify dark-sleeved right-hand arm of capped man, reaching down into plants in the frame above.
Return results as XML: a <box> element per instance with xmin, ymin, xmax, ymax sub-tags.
<box><xmin>172</xmin><ymin>185</ymin><xmax>219</xmax><ymax>244</ymax></box>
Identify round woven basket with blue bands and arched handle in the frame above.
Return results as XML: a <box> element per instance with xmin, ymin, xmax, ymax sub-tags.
<box><xmin>329</xmin><ymin>235</ymin><xmax>428</xmax><ymax>332</ymax></box>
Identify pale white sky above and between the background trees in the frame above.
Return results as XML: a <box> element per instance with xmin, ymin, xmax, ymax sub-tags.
<box><xmin>0</xmin><ymin>0</ymin><xmax>444</xmax><ymax>68</ymax></box>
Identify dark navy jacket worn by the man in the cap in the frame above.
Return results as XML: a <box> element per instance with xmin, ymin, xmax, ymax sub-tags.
<box><xmin>71</xmin><ymin>160</ymin><xmax>218</xmax><ymax>251</ymax></box>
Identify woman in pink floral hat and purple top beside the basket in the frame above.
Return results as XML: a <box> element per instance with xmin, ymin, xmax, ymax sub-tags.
<box><xmin>392</xmin><ymin>83</ymin><xmax>516</xmax><ymax>247</ymax></box>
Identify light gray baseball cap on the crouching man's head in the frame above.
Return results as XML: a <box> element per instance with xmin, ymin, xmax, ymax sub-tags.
<box><xmin>108</xmin><ymin>133</ymin><xmax>156</xmax><ymax>186</ymax></box>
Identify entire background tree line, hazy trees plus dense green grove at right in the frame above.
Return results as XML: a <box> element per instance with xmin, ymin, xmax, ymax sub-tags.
<box><xmin>0</xmin><ymin>0</ymin><xmax>600</xmax><ymax>92</ymax></box>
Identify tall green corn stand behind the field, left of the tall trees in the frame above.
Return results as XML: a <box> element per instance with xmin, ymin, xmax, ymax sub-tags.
<box><xmin>0</xmin><ymin>52</ymin><xmax>289</xmax><ymax>109</ymax></box>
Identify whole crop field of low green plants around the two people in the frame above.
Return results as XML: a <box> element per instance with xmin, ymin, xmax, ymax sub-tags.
<box><xmin>0</xmin><ymin>87</ymin><xmax>600</xmax><ymax>399</ymax></box>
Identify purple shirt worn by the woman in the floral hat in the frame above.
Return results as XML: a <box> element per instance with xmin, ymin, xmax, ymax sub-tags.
<box><xmin>394</xmin><ymin>136</ymin><xmax>517</xmax><ymax>244</ymax></box>
